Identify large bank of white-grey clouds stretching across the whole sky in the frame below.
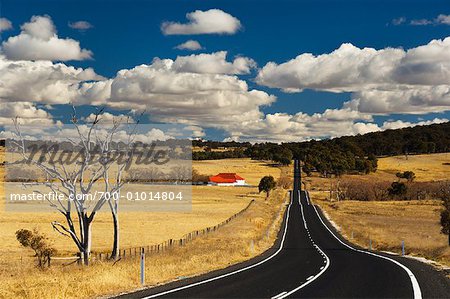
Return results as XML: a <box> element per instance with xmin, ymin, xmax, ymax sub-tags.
<box><xmin>0</xmin><ymin>22</ymin><xmax>450</xmax><ymax>142</ymax></box>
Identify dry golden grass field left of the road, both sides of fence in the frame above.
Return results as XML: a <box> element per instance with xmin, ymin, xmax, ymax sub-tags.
<box><xmin>0</xmin><ymin>150</ymin><xmax>285</xmax><ymax>298</ymax></box>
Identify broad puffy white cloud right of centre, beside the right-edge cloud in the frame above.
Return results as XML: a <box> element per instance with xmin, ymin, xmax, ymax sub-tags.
<box><xmin>256</xmin><ymin>40</ymin><xmax>404</xmax><ymax>92</ymax></box>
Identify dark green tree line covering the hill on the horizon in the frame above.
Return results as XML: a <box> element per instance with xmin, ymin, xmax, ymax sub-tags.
<box><xmin>192</xmin><ymin>122</ymin><xmax>450</xmax><ymax>176</ymax></box>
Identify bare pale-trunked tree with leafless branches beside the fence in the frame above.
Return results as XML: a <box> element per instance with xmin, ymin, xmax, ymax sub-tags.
<box><xmin>14</xmin><ymin>107</ymin><xmax>136</xmax><ymax>265</ymax></box>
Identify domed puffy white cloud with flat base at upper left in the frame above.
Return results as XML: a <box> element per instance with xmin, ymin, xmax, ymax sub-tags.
<box><xmin>2</xmin><ymin>16</ymin><xmax>92</xmax><ymax>61</ymax></box>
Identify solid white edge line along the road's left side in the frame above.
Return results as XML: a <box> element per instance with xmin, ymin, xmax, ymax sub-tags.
<box><xmin>141</xmin><ymin>192</ymin><xmax>293</xmax><ymax>299</ymax></box>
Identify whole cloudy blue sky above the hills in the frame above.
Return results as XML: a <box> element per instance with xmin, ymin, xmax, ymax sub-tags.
<box><xmin>0</xmin><ymin>0</ymin><xmax>450</xmax><ymax>142</ymax></box>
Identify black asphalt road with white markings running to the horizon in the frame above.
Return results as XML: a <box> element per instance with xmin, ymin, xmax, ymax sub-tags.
<box><xmin>121</xmin><ymin>162</ymin><xmax>450</xmax><ymax>299</ymax></box>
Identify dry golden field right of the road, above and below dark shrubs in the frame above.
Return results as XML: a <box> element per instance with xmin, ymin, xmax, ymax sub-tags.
<box><xmin>306</xmin><ymin>154</ymin><xmax>450</xmax><ymax>266</ymax></box>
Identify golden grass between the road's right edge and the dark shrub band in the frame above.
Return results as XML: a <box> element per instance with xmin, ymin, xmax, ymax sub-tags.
<box><xmin>310</xmin><ymin>191</ymin><xmax>450</xmax><ymax>266</ymax></box>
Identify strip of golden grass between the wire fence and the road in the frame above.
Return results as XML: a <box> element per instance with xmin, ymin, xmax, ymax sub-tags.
<box><xmin>0</xmin><ymin>191</ymin><xmax>286</xmax><ymax>298</ymax></box>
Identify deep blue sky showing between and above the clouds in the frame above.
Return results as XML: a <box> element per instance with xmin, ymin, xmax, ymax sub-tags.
<box><xmin>1</xmin><ymin>0</ymin><xmax>450</xmax><ymax>140</ymax></box>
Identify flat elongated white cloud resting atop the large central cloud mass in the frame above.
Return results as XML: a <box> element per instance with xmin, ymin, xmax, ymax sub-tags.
<box><xmin>172</xmin><ymin>51</ymin><xmax>256</xmax><ymax>74</ymax></box>
